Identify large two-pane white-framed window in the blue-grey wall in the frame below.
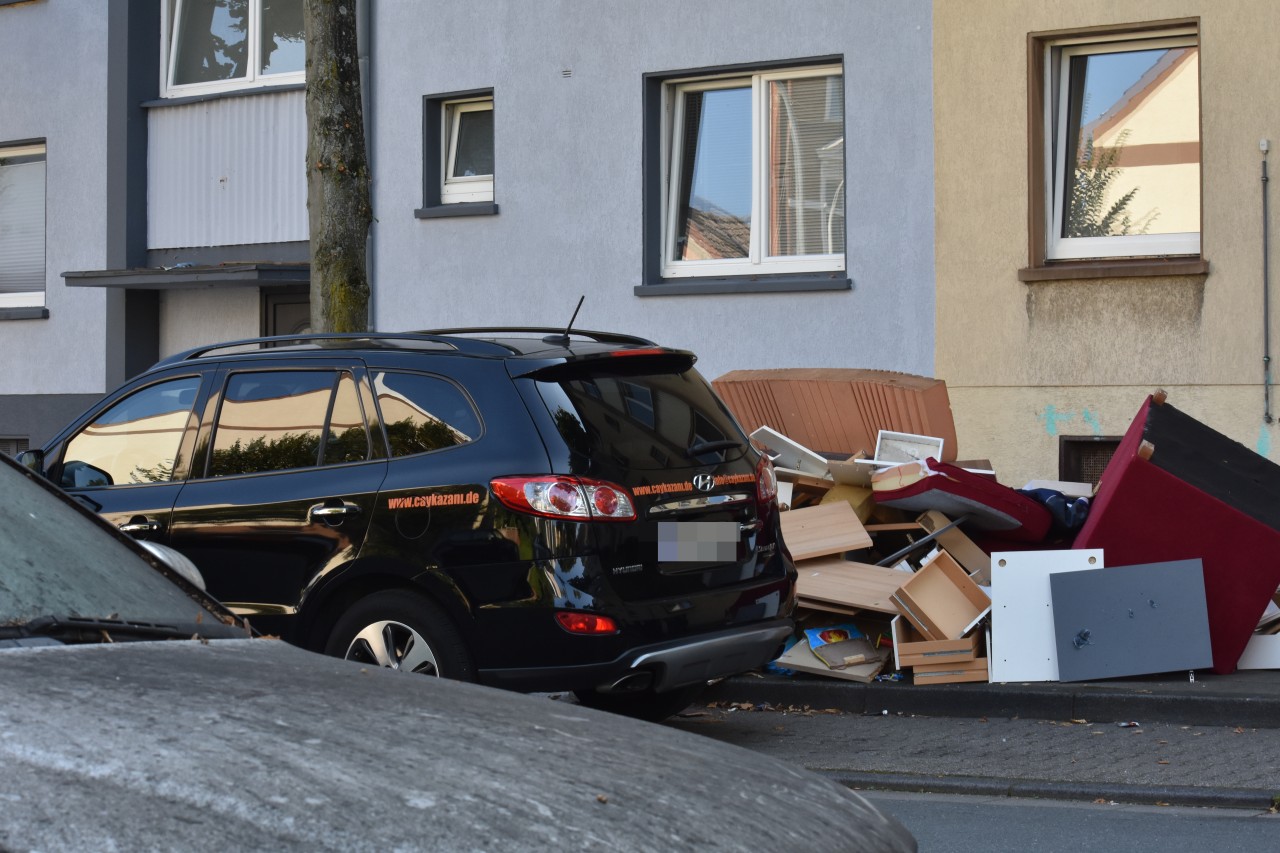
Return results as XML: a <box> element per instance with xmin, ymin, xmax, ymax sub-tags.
<box><xmin>662</xmin><ymin>65</ymin><xmax>846</xmax><ymax>278</ymax></box>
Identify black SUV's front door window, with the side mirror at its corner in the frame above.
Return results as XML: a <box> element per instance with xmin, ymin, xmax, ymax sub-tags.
<box><xmin>60</xmin><ymin>377</ymin><xmax>200</xmax><ymax>489</ymax></box>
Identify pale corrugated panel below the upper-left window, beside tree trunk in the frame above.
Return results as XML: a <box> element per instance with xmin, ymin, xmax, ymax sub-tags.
<box><xmin>147</xmin><ymin>91</ymin><xmax>307</xmax><ymax>248</ymax></box>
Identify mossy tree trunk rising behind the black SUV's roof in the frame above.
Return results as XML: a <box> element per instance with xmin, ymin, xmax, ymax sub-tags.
<box><xmin>303</xmin><ymin>0</ymin><xmax>372</xmax><ymax>332</ymax></box>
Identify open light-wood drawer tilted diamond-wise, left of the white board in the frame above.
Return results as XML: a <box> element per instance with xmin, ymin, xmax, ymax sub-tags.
<box><xmin>892</xmin><ymin>551</ymin><xmax>991</xmax><ymax>640</ymax></box>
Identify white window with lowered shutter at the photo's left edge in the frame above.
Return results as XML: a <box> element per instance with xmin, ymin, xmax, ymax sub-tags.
<box><xmin>0</xmin><ymin>145</ymin><xmax>45</xmax><ymax>309</ymax></box>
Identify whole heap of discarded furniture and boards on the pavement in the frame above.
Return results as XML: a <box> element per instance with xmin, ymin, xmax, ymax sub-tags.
<box><xmin>713</xmin><ymin>369</ymin><xmax>1280</xmax><ymax>684</ymax></box>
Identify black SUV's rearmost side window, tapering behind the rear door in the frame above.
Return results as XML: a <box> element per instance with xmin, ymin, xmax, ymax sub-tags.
<box><xmin>374</xmin><ymin>370</ymin><xmax>480</xmax><ymax>456</ymax></box>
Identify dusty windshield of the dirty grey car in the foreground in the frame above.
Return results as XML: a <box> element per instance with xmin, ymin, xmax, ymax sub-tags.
<box><xmin>0</xmin><ymin>457</ymin><xmax>235</xmax><ymax>627</ymax></box>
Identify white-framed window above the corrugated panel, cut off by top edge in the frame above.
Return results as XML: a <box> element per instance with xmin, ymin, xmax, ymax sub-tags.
<box><xmin>161</xmin><ymin>0</ymin><xmax>306</xmax><ymax>97</ymax></box>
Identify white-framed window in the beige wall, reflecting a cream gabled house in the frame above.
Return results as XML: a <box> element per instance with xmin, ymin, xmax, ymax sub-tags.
<box><xmin>1043</xmin><ymin>28</ymin><xmax>1201</xmax><ymax>260</ymax></box>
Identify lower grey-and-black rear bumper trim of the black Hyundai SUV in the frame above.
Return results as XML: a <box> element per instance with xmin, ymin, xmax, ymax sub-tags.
<box><xmin>479</xmin><ymin>619</ymin><xmax>795</xmax><ymax>693</ymax></box>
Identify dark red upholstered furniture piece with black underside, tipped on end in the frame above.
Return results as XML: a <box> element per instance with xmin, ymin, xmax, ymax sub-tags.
<box><xmin>1074</xmin><ymin>396</ymin><xmax>1280</xmax><ymax>674</ymax></box>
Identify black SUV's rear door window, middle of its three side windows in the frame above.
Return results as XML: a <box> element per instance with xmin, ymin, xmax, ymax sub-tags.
<box><xmin>209</xmin><ymin>370</ymin><xmax>369</xmax><ymax>476</ymax></box>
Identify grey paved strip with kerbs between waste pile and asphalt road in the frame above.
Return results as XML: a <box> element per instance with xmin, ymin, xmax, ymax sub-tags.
<box><xmin>696</xmin><ymin>670</ymin><xmax>1280</xmax><ymax>811</ymax></box>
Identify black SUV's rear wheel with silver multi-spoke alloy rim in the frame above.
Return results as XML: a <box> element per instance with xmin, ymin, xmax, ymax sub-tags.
<box><xmin>324</xmin><ymin>589</ymin><xmax>475</xmax><ymax>681</ymax></box>
